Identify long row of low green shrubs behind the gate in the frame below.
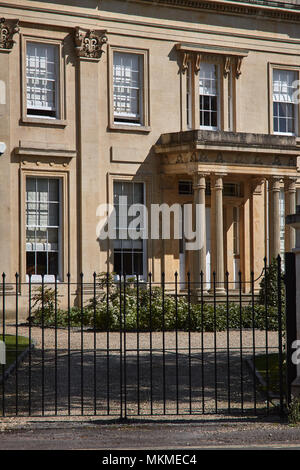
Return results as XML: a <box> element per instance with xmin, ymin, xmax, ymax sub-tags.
<box><xmin>31</xmin><ymin>274</ymin><xmax>284</xmax><ymax>332</ymax></box>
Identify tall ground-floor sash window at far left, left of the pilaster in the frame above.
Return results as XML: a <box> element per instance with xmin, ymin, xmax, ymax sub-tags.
<box><xmin>26</xmin><ymin>177</ymin><xmax>61</xmax><ymax>281</ymax></box>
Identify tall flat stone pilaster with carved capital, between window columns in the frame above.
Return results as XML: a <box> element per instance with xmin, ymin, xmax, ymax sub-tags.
<box><xmin>75</xmin><ymin>27</ymin><xmax>106</xmax><ymax>279</ymax></box>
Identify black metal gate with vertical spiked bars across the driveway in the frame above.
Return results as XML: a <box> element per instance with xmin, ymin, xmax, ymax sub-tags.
<box><xmin>0</xmin><ymin>257</ymin><xmax>289</xmax><ymax>418</ymax></box>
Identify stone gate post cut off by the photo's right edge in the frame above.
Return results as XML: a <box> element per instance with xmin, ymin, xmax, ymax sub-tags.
<box><xmin>286</xmin><ymin>205</ymin><xmax>300</xmax><ymax>400</ymax></box>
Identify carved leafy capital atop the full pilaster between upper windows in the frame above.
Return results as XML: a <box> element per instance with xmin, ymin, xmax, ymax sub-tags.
<box><xmin>75</xmin><ymin>26</ymin><xmax>107</xmax><ymax>60</ymax></box>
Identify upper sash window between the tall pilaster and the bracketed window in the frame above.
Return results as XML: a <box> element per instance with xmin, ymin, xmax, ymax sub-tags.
<box><xmin>113</xmin><ymin>52</ymin><xmax>143</xmax><ymax>124</ymax></box>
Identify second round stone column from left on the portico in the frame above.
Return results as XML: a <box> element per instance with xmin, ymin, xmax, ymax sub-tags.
<box><xmin>211</xmin><ymin>174</ymin><xmax>225</xmax><ymax>293</ymax></box>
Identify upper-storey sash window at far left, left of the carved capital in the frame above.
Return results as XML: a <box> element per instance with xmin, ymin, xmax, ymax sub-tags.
<box><xmin>26</xmin><ymin>41</ymin><xmax>59</xmax><ymax>119</ymax></box>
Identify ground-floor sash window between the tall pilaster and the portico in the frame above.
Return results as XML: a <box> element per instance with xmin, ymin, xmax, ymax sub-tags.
<box><xmin>113</xmin><ymin>181</ymin><xmax>146</xmax><ymax>277</ymax></box>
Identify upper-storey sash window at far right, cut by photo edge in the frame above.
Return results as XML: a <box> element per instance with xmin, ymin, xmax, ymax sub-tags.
<box><xmin>273</xmin><ymin>68</ymin><xmax>298</xmax><ymax>134</ymax></box>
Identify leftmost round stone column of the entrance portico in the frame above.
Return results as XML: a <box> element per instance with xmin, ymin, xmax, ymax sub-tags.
<box><xmin>192</xmin><ymin>173</ymin><xmax>207</xmax><ymax>291</ymax></box>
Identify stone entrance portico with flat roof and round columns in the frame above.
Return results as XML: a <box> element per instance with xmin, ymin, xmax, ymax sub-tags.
<box><xmin>155</xmin><ymin>131</ymin><xmax>299</xmax><ymax>293</ymax></box>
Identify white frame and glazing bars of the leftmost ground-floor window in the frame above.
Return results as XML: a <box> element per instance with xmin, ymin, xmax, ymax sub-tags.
<box><xmin>25</xmin><ymin>175</ymin><xmax>63</xmax><ymax>283</ymax></box>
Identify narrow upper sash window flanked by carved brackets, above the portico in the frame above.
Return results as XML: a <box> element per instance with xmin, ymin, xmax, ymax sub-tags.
<box><xmin>199</xmin><ymin>62</ymin><xmax>219</xmax><ymax>130</ymax></box>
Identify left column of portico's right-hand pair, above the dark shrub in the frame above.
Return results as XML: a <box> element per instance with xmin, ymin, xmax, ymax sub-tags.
<box><xmin>269</xmin><ymin>176</ymin><xmax>281</xmax><ymax>262</ymax></box>
